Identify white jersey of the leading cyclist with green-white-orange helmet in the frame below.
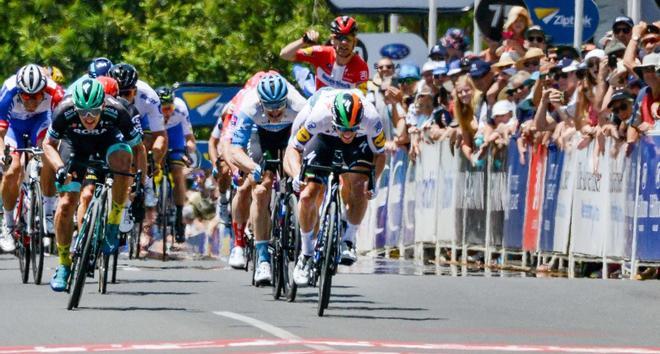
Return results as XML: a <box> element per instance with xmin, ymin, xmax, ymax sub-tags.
<box><xmin>290</xmin><ymin>90</ymin><xmax>385</xmax><ymax>154</ymax></box>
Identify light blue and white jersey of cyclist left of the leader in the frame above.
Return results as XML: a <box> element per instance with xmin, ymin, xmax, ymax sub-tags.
<box><xmin>232</xmin><ymin>83</ymin><xmax>305</xmax><ymax>147</ymax></box>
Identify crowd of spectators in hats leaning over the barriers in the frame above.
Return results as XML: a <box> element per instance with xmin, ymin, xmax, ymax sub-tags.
<box><xmin>367</xmin><ymin>6</ymin><xmax>660</xmax><ymax>168</ymax></box>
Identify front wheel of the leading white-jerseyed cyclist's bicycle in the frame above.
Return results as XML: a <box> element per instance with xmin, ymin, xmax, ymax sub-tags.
<box><xmin>317</xmin><ymin>201</ymin><xmax>337</xmax><ymax>316</ymax></box>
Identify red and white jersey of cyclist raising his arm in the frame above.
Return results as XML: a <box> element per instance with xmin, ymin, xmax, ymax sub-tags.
<box><xmin>296</xmin><ymin>45</ymin><xmax>369</xmax><ymax>90</ymax></box>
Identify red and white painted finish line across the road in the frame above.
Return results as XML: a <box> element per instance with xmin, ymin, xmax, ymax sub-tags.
<box><xmin>0</xmin><ymin>339</ymin><xmax>660</xmax><ymax>354</ymax></box>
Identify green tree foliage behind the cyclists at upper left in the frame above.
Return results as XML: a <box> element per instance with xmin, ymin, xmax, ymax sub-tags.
<box><xmin>0</xmin><ymin>0</ymin><xmax>472</xmax><ymax>85</ymax></box>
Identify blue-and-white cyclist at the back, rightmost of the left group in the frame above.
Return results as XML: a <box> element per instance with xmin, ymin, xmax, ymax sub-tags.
<box><xmin>156</xmin><ymin>86</ymin><xmax>195</xmax><ymax>243</ymax></box>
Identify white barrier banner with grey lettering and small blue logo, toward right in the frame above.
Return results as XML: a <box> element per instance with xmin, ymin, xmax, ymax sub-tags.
<box><xmin>571</xmin><ymin>143</ymin><xmax>609</xmax><ymax>256</ymax></box>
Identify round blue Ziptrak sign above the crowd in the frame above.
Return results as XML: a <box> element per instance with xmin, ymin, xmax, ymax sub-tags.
<box><xmin>525</xmin><ymin>0</ymin><xmax>600</xmax><ymax>45</ymax></box>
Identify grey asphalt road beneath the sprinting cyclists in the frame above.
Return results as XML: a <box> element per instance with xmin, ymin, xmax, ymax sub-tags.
<box><xmin>0</xmin><ymin>255</ymin><xmax>660</xmax><ymax>353</ymax></box>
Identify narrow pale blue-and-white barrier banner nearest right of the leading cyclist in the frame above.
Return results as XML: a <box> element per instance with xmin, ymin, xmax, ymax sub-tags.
<box><xmin>385</xmin><ymin>148</ymin><xmax>408</xmax><ymax>247</ymax></box>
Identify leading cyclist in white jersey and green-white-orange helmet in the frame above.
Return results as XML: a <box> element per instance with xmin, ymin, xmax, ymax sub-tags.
<box><xmin>287</xmin><ymin>90</ymin><xmax>385</xmax><ymax>286</ymax></box>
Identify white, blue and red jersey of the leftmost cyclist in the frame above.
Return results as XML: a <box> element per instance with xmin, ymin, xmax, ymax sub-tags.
<box><xmin>0</xmin><ymin>75</ymin><xmax>64</xmax><ymax>148</ymax></box>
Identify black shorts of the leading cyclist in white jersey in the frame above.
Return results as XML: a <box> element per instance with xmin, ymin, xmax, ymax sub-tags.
<box><xmin>303</xmin><ymin>134</ymin><xmax>374</xmax><ymax>181</ymax></box>
